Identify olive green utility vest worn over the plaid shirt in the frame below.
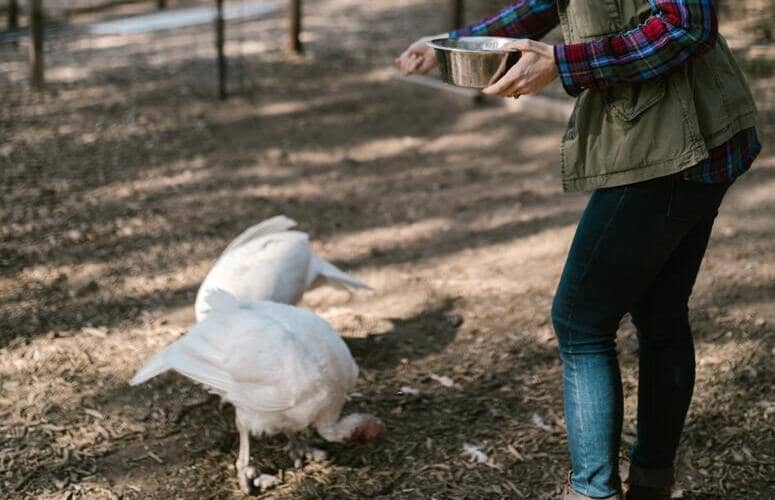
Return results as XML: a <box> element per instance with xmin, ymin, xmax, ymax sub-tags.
<box><xmin>558</xmin><ymin>0</ymin><xmax>756</xmax><ymax>191</ymax></box>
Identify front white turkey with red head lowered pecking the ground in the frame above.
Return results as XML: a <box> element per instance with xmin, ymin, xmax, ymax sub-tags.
<box><xmin>130</xmin><ymin>290</ymin><xmax>384</xmax><ymax>492</ymax></box>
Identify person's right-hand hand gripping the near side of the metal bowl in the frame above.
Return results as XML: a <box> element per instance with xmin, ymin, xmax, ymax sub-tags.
<box><xmin>482</xmin><ymin>40</ymin><xmax>558</xmax><ymax>97</ymax></box>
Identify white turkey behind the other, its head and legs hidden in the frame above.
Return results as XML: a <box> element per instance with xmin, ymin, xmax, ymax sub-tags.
<box><xmin>194</xmin><ymin>215</ymin><xmax>369</xmax><ymax>321</ymax></box>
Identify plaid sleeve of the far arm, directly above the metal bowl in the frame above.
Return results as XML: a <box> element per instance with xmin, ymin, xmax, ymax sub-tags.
<box><xmin>449</xmin><ymin>0</ymin><xmax>560</xmax><ymax>40</ymax></box>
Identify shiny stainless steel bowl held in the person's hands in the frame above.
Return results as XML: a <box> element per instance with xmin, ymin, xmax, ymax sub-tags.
<box><xmin>428</xmin><ymin>36</ymin><xmax>522</xmax><ymax>88</ymax></box>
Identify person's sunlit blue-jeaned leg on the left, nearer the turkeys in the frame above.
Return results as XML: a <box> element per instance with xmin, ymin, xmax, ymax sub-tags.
<box><xmin>552</xmin><ymin>177</ymin><xmax>708</xmax><ymax>498</ymax></box>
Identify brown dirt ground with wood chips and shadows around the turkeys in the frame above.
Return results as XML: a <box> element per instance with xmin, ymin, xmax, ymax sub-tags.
<box><xmin>0</xmin><ymin>0</ymin><xmax>775</xmax><ymax>499</ymax></box>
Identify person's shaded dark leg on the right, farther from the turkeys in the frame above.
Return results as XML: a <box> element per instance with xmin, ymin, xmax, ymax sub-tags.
<box><xmin>629</xmin><ymin>179</ymin><xmax>726</xmax><ymax>490</ymax></box>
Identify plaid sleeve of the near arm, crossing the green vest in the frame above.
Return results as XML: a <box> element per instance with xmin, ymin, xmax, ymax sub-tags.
<box><xmin>554</xmin><ymin>0</ymin><xmax>718</xmax><ymax>96</ymax></box>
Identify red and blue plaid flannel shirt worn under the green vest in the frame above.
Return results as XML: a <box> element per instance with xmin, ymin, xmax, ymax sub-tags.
<box><xmin>449</xmin><ymin>0</ymin><xmax>761</xmax><ymax>183</ymax></box>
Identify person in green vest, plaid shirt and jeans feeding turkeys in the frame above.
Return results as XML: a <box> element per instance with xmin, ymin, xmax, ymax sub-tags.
<box><xmin>396</xmin><ymin>0</ymin><xmax>761</xmax><ymax>500</ymax></box>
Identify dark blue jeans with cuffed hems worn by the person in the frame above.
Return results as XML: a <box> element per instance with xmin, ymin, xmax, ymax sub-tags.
<box><xmin>552</xmin><ymin>176</ymin><xmax>729</xmax><ymax>498</ymax></box>
